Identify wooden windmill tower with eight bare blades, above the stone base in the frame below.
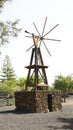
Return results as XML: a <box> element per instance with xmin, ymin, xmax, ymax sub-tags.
<box><xmin>25</xmin><ymin>17</ymin><xmax>60</xmax><ymax>90</ymax></box>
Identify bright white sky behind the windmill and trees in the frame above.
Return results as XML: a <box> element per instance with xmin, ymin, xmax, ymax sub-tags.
<box><xmin>0</xmin><ymin>0</ymin><xmax>73</xmax><ymax>85</ymax></box>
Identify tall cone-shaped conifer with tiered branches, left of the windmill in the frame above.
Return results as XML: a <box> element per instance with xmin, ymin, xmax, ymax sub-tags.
<box><xmin>1</xmin><ymin>55</ymin><xmax>16</xmax><ymax>82</ymax></box>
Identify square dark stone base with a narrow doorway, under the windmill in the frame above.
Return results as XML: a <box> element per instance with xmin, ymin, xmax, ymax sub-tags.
<box><xmin>15</xmin><ymin>90</ymin><xmax>62</xmax><ymax>113</ymax></box>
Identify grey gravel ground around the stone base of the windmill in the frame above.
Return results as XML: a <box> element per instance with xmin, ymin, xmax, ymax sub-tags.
<box><xmin>0</xmin><ymin>96</ymin><xmax>73</xmax><ymax>130</ymax></box>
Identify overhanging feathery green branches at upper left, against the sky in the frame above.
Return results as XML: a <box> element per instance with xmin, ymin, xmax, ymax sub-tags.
<box><xmin>0</xmin><ymin>0</ymin><xmax>21</xmax><ymax>50</ymax></box>
